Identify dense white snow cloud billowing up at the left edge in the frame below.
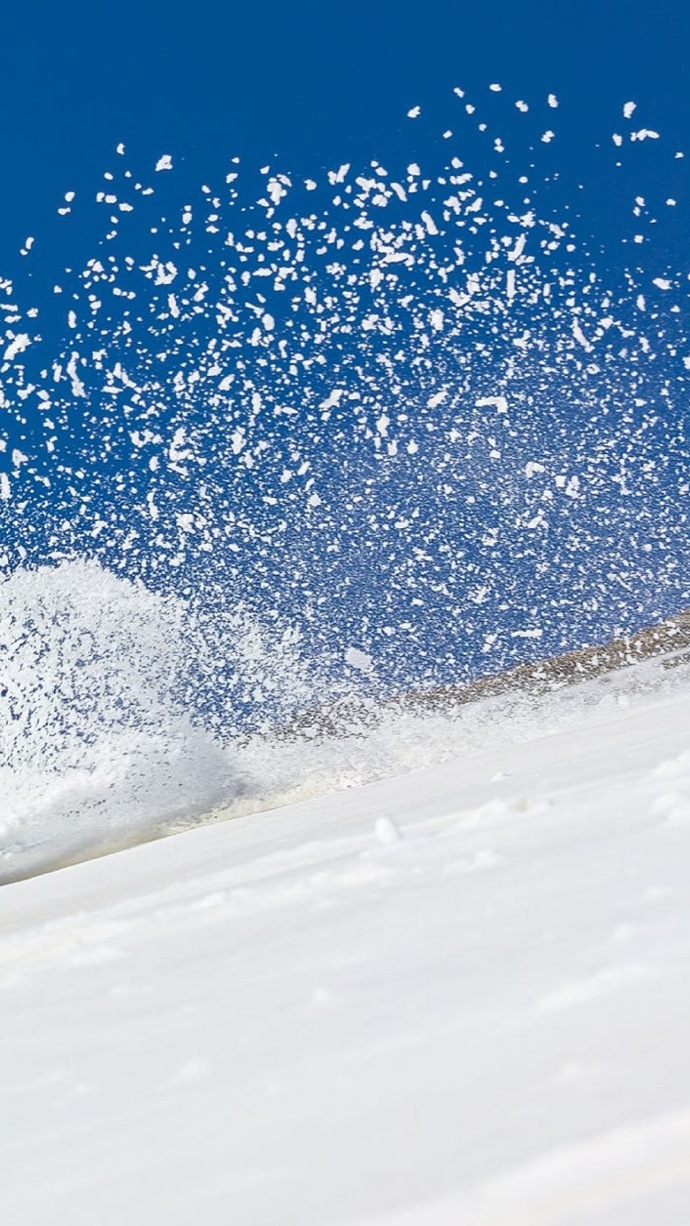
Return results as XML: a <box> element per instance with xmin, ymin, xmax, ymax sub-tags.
<box><xmin>0</xmin><ymin>562</ymin><xmax>316</xmax><ymax>878</ymax></box>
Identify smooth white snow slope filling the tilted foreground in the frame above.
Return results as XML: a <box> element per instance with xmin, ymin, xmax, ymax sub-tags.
<box><xmin>0</xmin><ymin>685</ymin><xmax>690</xmax><ymax>1226</ymax></box>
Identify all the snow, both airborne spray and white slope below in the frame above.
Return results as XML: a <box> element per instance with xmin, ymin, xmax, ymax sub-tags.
<box><xmin>0</xmin><ymin>83</ymin><xmax>690</xmax><ymax>1226</ymax></box>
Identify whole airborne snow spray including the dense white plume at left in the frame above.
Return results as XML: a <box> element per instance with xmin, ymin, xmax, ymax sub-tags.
<box><xmin>0</xmin><ymin>83</ymin><xmax>690</xmax><ymax>872</ymax></box>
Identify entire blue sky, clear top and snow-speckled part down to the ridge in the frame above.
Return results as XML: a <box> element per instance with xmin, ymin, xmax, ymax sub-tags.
<box><xmin>0</xmin><ymin>0</ymin><xmax>690</xmax><ymax>701</ymax></box>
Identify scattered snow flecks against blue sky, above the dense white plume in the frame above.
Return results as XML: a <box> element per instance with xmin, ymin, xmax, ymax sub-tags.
<box><xmin>0</xmin><ymin>89</ymin><xmax>690</xmax><ymax>701</ymax></box>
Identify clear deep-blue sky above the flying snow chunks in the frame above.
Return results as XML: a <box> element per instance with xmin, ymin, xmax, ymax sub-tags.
<box><xmin>0</xmin><ymin>0</ymin><xmax>690</xmax><ymax>256</ymax></box>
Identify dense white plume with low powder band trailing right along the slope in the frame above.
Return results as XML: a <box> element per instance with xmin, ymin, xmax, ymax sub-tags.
<box><xmin>0</xmin><ymin>562</ymin><xmax>690</xmax><ymax>884</ymax></box>
